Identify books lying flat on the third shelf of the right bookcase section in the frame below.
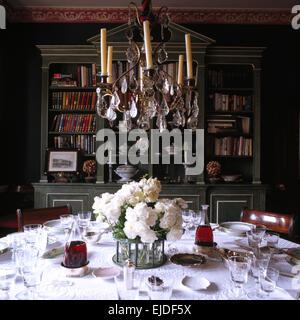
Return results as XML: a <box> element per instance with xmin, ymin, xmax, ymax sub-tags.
<box><xmin>207</xmin><ymin>114</ymin><xmax>251</xmax><ymax>135</ymax></box>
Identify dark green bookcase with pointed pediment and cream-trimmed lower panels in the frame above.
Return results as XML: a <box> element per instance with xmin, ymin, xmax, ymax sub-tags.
<box><xmin>33</xmin><ymin>23</ymin><xmax>266</xmax><ymax>222</ymax></box>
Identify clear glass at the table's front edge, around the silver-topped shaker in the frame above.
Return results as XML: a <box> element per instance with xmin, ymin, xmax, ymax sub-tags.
<box><xmin>114</xmin><ymin>271</ymin><xmax>140</xmax><ymax>300</ymax></box>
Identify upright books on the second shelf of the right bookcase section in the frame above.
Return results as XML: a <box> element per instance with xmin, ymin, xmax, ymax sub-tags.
<box><xmin>210</xmin><ymin>92</ymin><xmax>252</xmax><ymax>111</ymax></box>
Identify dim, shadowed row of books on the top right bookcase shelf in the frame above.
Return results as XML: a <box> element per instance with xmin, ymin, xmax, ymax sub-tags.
<box><xmin>208</xmin><ymin>69</ymin><xmax>252</xmax><ymax>88</ymax></box>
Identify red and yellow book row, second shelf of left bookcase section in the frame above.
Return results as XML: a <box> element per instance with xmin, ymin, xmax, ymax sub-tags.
<box><xmin>51</xmin><ymin>91</ymin><xmax>97</xmax><ymax>110</ymax></box>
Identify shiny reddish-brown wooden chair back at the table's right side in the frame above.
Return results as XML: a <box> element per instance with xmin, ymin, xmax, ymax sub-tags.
<box><xmin>240</xmin><ymin>208</ymin><xmax>296</xmax><ymax>238</ymax></box>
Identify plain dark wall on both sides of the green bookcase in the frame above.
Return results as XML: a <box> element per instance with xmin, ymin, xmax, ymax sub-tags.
<box><xmin>0</xmin><ymin>23</ymin><xmax>300</xmax><ymax>209</ymax></box>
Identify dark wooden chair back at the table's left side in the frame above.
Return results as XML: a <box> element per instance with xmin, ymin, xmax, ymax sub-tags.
<box><xmin>17</xmin><ymin>204</ymin><xmax>72</xmax><ymax>232</ymax></box>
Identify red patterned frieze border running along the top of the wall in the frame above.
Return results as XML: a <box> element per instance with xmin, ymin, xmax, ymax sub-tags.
<box><xmin>7</xmin><ymin>7</ymin><xmax>293</xmax><ymax>25</ymax></box>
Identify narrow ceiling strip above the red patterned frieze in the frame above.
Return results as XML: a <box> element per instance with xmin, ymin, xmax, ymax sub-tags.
<box><xmin>6</xmin><ymin>0</ymin><xmax>299</xmax><ymax>9</ymax></box>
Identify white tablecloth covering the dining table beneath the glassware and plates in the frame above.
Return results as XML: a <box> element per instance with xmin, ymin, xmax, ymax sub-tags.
<box><xmin>0</xmin><ymin>230</ymin><xmax>300</xmax><ymax>300</ymax></box>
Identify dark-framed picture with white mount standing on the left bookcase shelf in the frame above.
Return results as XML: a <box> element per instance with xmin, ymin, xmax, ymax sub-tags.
<box><xmin>45</xmin><ymin>149</ymin><xmax>81</xmax><ymax>182</ymax></box>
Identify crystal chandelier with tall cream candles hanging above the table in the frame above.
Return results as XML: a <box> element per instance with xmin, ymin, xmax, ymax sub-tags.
<box><xmin>96</xmin><ymin>0</ymin><xmax>199</xmax><ymax>131</ymax></box>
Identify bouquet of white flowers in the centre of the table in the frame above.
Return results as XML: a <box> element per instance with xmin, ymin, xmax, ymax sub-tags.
<box><xmin>93</xmin><ymin>178</ymin><xmax>187</xmax><ymax>243</ymax></box>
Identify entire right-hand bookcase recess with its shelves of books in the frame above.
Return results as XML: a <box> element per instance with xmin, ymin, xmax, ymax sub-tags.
<box><xmin>205</xmin><ymin>59</ymin><xmax>260</xmax><ymax>182</ymax></box>
